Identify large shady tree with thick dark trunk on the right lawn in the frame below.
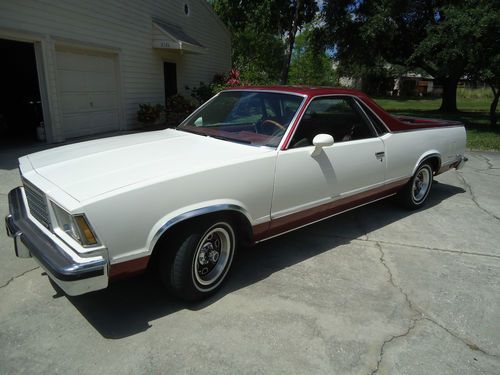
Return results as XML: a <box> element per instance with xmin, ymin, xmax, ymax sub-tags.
<box><xmin>324</xmin><ymin>0</ymin><xmax>492</xmax><ymax>112</ymax></box>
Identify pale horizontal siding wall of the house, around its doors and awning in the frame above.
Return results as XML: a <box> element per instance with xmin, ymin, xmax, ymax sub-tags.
<box><xmin>0</xmin><ymin>0</ymin><xmax>231</xmax><ymax>141</ymax></box>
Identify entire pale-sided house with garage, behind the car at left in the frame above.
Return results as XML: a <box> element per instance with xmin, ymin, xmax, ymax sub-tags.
<box><xmin>0</xmin><ymin>0</ymin><xmax>231</xmax><ymax>142</ymax></box>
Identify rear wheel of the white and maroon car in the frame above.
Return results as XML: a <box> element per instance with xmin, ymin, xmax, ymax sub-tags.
<box><xmin>398</xmin><ymin>163</ymin><xmax>433</xmax><ymax>210</ymax></box>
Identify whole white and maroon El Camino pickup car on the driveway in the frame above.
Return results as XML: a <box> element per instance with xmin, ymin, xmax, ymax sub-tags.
<box><xmin>6</xmin><ymin>87</ymin><xmax>466</xmax><ymax>300</ymax></box>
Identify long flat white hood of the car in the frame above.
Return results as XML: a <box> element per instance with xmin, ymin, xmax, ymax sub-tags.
<box><xmin>27</xmin><ymin>129</ymin><xmax>272</xmax><ymax>202</ymax></box>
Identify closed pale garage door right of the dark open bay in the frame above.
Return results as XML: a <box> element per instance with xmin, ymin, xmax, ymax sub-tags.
<box><xmin>57</xmin><ymin>51</ymin><xmax>120</xmax><ymax>138</ymax></box>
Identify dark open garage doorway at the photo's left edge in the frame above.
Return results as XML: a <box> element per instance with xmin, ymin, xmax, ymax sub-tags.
<box><xmin>0</xmin><ymin>39</ymin><xmax>44</xmax><ymax>143</ymax></box>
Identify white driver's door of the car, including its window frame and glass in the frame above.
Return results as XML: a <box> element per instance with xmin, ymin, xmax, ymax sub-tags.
<box><xmin>271</xmin><ymin>96</ymin><xmax>385</xmax><ymax>228</ymax></box>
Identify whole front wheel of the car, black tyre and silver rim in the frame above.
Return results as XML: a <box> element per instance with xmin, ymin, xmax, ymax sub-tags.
<box><xmin>160</xmin><ymin>220</ymin><xmax>236</xmax><ymax>301</ymax></box>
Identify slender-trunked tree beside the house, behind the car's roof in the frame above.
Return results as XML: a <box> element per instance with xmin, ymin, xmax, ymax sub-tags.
<box><xmin>211</xmin><ymin>0</ymin><xmax>318</xmax><ymax>84</ymax></box>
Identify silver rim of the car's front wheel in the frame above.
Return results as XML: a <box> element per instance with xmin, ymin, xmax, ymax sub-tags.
<box><xmin>193</xmin><ymin>226</ymin><xmax>234</xmax><ymax>290</ymax></box>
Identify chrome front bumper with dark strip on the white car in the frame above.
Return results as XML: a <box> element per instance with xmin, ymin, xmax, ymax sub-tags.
<box><xmin>5</xmin><ymin>187</ymin><xmax>108</xmax><ymax>296</ymax></box>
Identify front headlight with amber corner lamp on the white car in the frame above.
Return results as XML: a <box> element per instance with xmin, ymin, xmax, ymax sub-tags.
<box><xmin>52</xmin><ymin>202</ymin><xmax>97</xmax><ymax>246</ymax></box>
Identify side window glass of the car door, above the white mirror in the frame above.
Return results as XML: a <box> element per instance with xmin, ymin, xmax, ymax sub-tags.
<box><xmin>291</xmin><ymin>97</ymin><xmax>376</xmax><ymax>148</ymax></box>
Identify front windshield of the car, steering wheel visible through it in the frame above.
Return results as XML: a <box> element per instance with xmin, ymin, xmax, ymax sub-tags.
<box><xmin>177</xmin><ymin>91</ymin><xmax>303</xmax><ymax>147</ymax></box>
